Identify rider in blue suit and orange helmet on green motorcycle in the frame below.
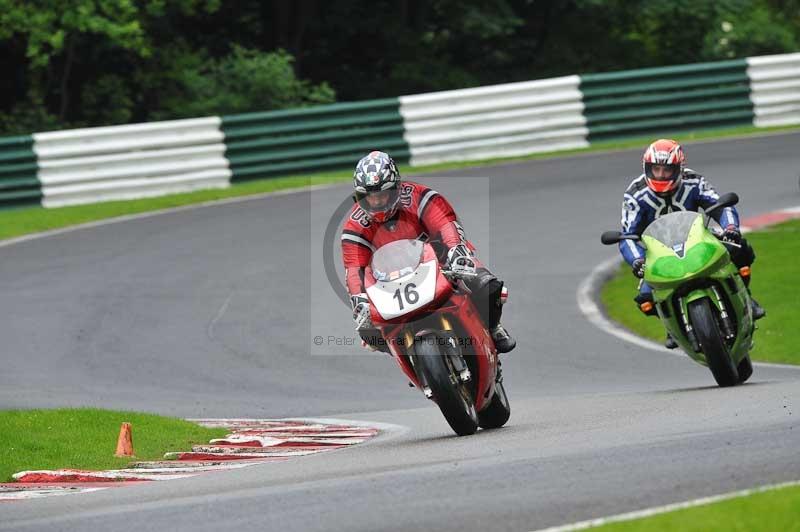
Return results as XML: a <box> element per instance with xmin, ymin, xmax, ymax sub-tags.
<box><xmin>619</xmin><ymin>139</ymin><xmax>766</xmax><ymax>349</ymax></box>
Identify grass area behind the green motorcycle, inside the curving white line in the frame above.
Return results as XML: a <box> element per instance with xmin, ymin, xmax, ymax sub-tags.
<box><xmin>600</xmin><ymin>220</ymin><xmax>800</xmax><ymax>364</ymax></box>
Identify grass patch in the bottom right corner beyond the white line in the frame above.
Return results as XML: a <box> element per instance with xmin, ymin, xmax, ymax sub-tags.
<box><xmin>592</xmin><ymin>486</ymin><xmax>800</xmax><ymax>532</ymax></box>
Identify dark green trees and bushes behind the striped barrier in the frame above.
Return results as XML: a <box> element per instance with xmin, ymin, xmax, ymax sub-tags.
<box><xmin>0</xmin><ymin>0</ymin><xmax>800</xmax><ymax>134</ymax></box>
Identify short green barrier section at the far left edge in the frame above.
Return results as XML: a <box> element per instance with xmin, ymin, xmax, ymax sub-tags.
<box><xmin>0</xmin><ymin>136</ymin><xmax>42</xmax><ymax>208</ymax></box>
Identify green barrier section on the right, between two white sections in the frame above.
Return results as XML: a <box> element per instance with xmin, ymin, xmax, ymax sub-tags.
<box><xmin>581</xmin><ymin>59</ymin><xmax>753</xmax><ymax>142</ymax></box>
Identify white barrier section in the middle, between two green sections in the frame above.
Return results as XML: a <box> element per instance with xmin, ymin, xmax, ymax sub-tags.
<box><xmin>400</xmin><ymin>76</ymin><xmax>589</xmax><ymax>166</ymax></box>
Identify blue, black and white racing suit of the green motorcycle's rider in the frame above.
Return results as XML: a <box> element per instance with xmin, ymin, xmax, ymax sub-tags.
<box><xmin>619</xmin><ymin>168</ymin><xmax>755</xmax><ymax>315</ymax></box>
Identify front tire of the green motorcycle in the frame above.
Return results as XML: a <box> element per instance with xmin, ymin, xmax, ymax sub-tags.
<box><xmin>689</xmin><ymin>298</ymin><xmax>739</xmax><ymax>387</ymax></box>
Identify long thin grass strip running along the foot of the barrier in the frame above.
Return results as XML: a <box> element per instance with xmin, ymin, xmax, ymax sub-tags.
<box><xmin>0</xmin><ymin>126</ymin><xmax>800</xmax><ymax>240</ymax></box>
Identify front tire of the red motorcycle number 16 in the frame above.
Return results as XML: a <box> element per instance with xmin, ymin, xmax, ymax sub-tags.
<box><xmin>414</xmin><ymin>335</ymin><xmax>478</xmax><ymax>436</ymax></box>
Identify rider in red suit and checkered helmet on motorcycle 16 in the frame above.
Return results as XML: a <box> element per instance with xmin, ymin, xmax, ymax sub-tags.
<box><xmin>342</xmin><ymin>151</ymin><xmax>516</xmax><ymax>353</ymax></box>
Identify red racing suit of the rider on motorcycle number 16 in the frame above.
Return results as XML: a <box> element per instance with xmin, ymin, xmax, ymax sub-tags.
<box><xmin>341</xmin><ymin>181</ymin><xmax>503</xmax><ymax>352</ymax></box>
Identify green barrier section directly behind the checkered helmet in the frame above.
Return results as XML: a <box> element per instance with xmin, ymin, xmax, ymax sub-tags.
<box><xmin>222</xmin><ymin>98</ymin><xmax>409</xmax><ymax>181</ymax></box>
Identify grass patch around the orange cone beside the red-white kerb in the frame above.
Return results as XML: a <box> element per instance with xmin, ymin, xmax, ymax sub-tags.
<box><xmin>0</xmin><ymin>408</ymin><xmax>227</xmax><ymax>482</ymax></box>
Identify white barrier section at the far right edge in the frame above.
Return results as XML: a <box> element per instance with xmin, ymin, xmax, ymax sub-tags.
<box><xmin>747</xmin><ymin>53</ymin><xmax>800</xmax><ymax>127</ymax></box>
